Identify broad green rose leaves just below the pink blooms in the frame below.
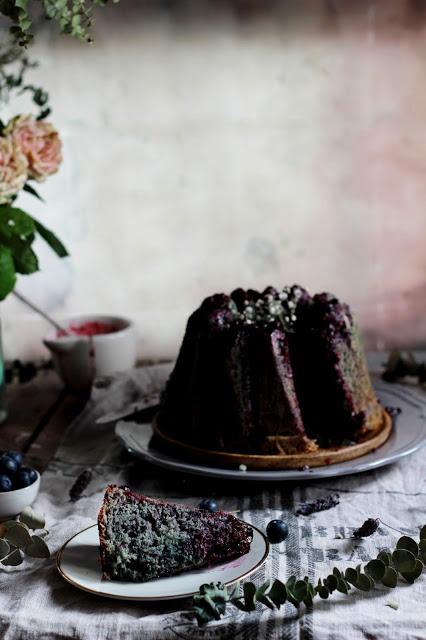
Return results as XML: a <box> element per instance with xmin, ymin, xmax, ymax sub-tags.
<box><xmin>0</xmin><ymin>206</ymin><xmax>68</xmax><ymax>300</ymax></box>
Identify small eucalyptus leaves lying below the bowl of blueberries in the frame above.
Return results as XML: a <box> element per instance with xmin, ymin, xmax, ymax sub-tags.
<box><xmin>0</xmin><ymin>507</ymin><xmax>50</xmax><ymax>567</ymax></box>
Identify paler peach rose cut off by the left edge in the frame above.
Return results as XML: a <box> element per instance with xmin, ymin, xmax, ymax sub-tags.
<box><xmin>0</xmin><ymin>135</ymin><xmax>28</xmax><ymax>204</ymax></box>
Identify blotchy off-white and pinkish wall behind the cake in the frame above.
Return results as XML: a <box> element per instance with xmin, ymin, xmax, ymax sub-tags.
<box><xmin>1</xmin><ymin>0</ymin><xmax>426</xmax><ymax>357</ymax></box>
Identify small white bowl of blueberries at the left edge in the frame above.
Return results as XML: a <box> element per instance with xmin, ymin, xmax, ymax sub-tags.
<box><xmin>0</xmin><ymin>451</ymin><xmax>40</xmax><ymax>519</ymax></box>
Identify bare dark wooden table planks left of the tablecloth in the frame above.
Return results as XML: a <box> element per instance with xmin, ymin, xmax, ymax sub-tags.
<box><xmin>0</xmin><ymin>370</ymin><xmax>88</xmax><ymax>472</ymax></box>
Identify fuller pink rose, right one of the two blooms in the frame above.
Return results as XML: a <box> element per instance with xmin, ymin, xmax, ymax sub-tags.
<box><xmin>5</xmin><ymin>115</ymin><xmax>62</xmax><ymax>182</ymax></box>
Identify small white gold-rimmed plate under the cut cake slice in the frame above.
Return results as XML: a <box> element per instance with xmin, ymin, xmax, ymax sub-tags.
<box><xmin>56</xmin><ymin>524</ymin><xmax>269</xmax><ymax>600</ymax></box>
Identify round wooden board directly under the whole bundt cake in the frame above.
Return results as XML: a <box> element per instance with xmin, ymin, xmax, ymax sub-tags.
<box><xmin>153</xmin><ymin>409</ymin><xmax>392</xmax><ymax>470</ymax></box>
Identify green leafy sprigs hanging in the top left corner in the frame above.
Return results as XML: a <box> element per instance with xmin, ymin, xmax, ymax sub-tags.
<box><xmin>0</xmin><ymin>0</ymin><xmax>118</xmax><ymax>47</ymax></box>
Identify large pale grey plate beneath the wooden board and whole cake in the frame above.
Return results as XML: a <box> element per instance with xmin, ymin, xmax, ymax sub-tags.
<box><xmin>115</xmin><ymin>382</ymin><xmax>426</xmax><ymax>482</ymax></box>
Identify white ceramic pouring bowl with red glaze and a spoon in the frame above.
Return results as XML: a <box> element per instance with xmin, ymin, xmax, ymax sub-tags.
<box><xmin>43</xmin><ymin>314</ymin><xmax>136</xmax><ymax>391</ymax></box>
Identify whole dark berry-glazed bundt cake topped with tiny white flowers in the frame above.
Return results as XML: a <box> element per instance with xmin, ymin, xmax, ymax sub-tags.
<box><xmin>158</xmin><ymin>285</ymin><xmax>382</xmax><ymax>454</ymax></box>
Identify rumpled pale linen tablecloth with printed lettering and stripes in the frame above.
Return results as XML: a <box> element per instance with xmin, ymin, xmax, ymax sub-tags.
<box><xmin>0</xmin><ymin>365</ymin><xmax>426</xmax><ymax>640</ymax></box>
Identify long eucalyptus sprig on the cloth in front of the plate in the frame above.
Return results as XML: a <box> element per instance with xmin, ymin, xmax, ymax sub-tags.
<box><xmin>193</xmin><ymin>525</ymin><xmax>426</xmax><ymax>626</ymax></box>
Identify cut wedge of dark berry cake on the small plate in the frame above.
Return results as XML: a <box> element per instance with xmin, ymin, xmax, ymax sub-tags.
<box><xmin>98</xmin><ymin>485</ymin><xmax>253</xmax><ymax>582</ymax></box>
